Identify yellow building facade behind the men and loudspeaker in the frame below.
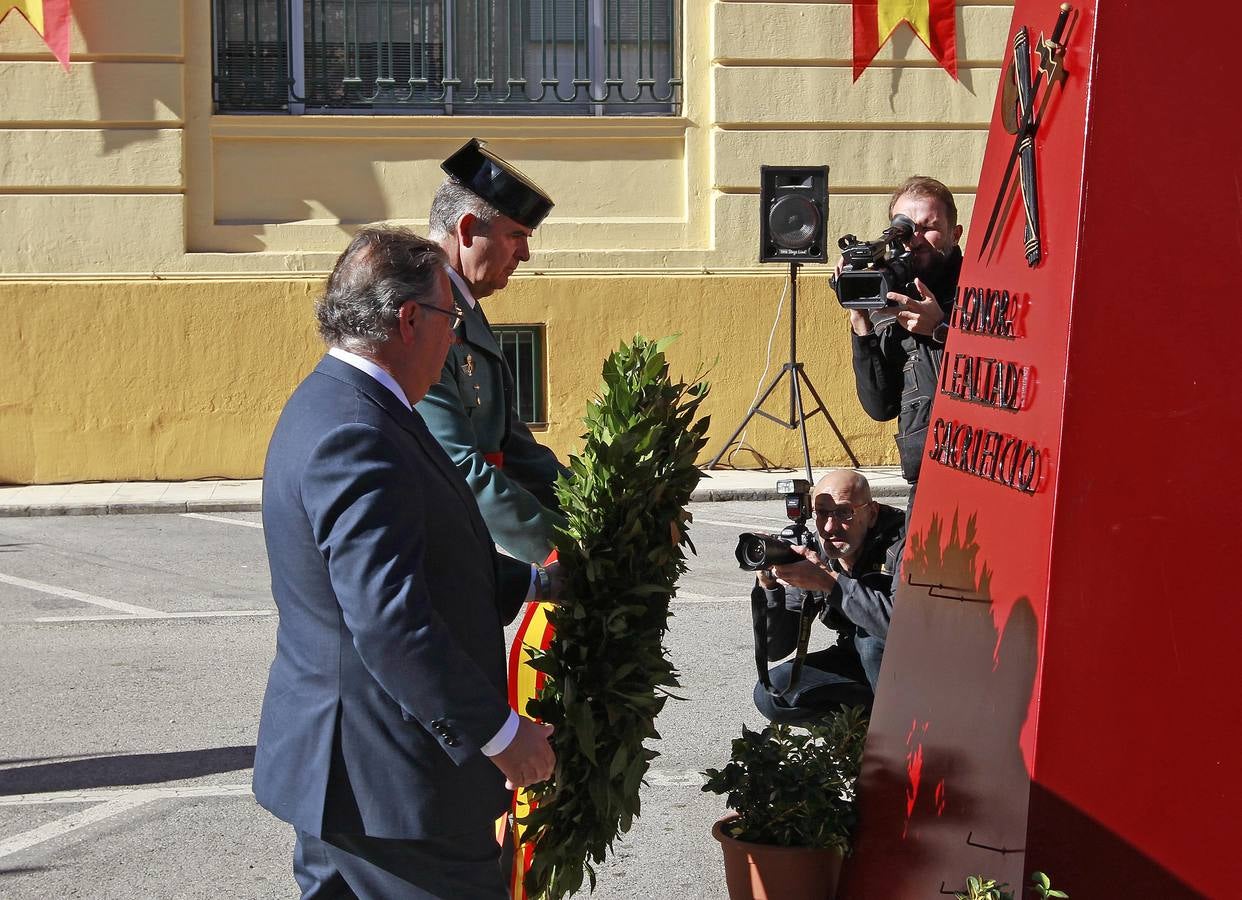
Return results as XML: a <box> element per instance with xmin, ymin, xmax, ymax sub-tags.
<box><xmin>0</xmin><ymin>0</ymin><xmax>1012</xmax><ymax>483</ymax></box>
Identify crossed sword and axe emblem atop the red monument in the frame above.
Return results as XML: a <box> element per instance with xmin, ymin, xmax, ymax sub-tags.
<box><xmin>979</xmin><ymin>4</ymin><xmax>1072</xmax><ymax>268</ymax></box>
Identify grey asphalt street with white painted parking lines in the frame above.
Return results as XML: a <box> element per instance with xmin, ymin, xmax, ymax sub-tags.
<box><xmin>0</xmin><ymin>500</ymin><xmax>904</xmax><ymax>900</ymax></box>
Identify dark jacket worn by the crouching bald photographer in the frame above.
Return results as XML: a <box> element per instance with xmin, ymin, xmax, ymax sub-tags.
<box><xmin>766</xmin><ymin>503</ymin><xmax>905</xmax><ymax>660</ymax></box>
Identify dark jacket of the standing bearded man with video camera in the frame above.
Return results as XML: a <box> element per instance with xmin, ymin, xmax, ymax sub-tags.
<box><xmin>851</xmin><ymin>247</ymin><xmax>961</xmax><ymax>484</ymax></box>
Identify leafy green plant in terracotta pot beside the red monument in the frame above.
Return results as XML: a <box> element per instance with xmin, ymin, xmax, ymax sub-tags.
<box><xmin>703</xmin><ymin>706</ymin><xmax>867</xmax><ymax>900</ymax></box>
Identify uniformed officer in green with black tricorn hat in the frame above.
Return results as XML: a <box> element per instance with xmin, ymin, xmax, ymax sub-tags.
<box><xmin>419</xmin><ymin>140</ymin><xmax>565</xmax><ymax>562</ymax></box>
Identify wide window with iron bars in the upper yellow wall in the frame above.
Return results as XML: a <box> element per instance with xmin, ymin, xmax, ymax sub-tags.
<box><xmin>212</xmin><ymin>0</ymin><xmax>682</xmax><ymax>115</ymax></box>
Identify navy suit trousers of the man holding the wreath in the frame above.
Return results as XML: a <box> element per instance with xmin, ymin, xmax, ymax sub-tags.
<box><xmin>293</xmin><ymin>828</ymin><xmax>509</xmax><ymax>900</ymax></box>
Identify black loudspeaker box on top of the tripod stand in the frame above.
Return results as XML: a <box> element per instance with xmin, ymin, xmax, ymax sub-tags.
<box><xmin>759</xmin><ymin>165</ymin><xmax>828</xmax><ymax>262</ymax></box>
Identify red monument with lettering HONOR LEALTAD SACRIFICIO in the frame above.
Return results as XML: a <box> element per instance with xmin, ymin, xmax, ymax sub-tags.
<box><xmin>841</xmin><ymin>0</ymin><xmax>1242</xmax><ymax>900</ymax></box>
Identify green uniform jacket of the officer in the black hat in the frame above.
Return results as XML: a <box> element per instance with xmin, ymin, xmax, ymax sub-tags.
<box><xmin>417</xmin><ymin>284</ymin><xmax>565</xmax><ymax>562</ymax></box>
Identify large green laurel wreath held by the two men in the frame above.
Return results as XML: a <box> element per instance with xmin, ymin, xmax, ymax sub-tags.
<box><xmin>523</xmin><ymin>336</ymin><xmax>708</xmax><ymax>900</ymax></box>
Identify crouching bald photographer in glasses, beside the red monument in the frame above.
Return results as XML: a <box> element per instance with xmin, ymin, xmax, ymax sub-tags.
<box><xmin>739</xmin><ymin>469</ymin><xmax>905</xmax><ymax>724</ymax></box>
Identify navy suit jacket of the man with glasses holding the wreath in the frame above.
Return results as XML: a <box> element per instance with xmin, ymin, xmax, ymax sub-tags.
<box><xmin>255</xmin><ymin>356</ymin><xmax>530</xmax><ymax>838</ymax></box>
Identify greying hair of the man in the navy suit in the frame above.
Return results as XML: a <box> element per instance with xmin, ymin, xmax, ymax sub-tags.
<box><xmin>314</xmin><ymin>226</ymin><xmax>448</xmax><ymax>353</ymax></box>
